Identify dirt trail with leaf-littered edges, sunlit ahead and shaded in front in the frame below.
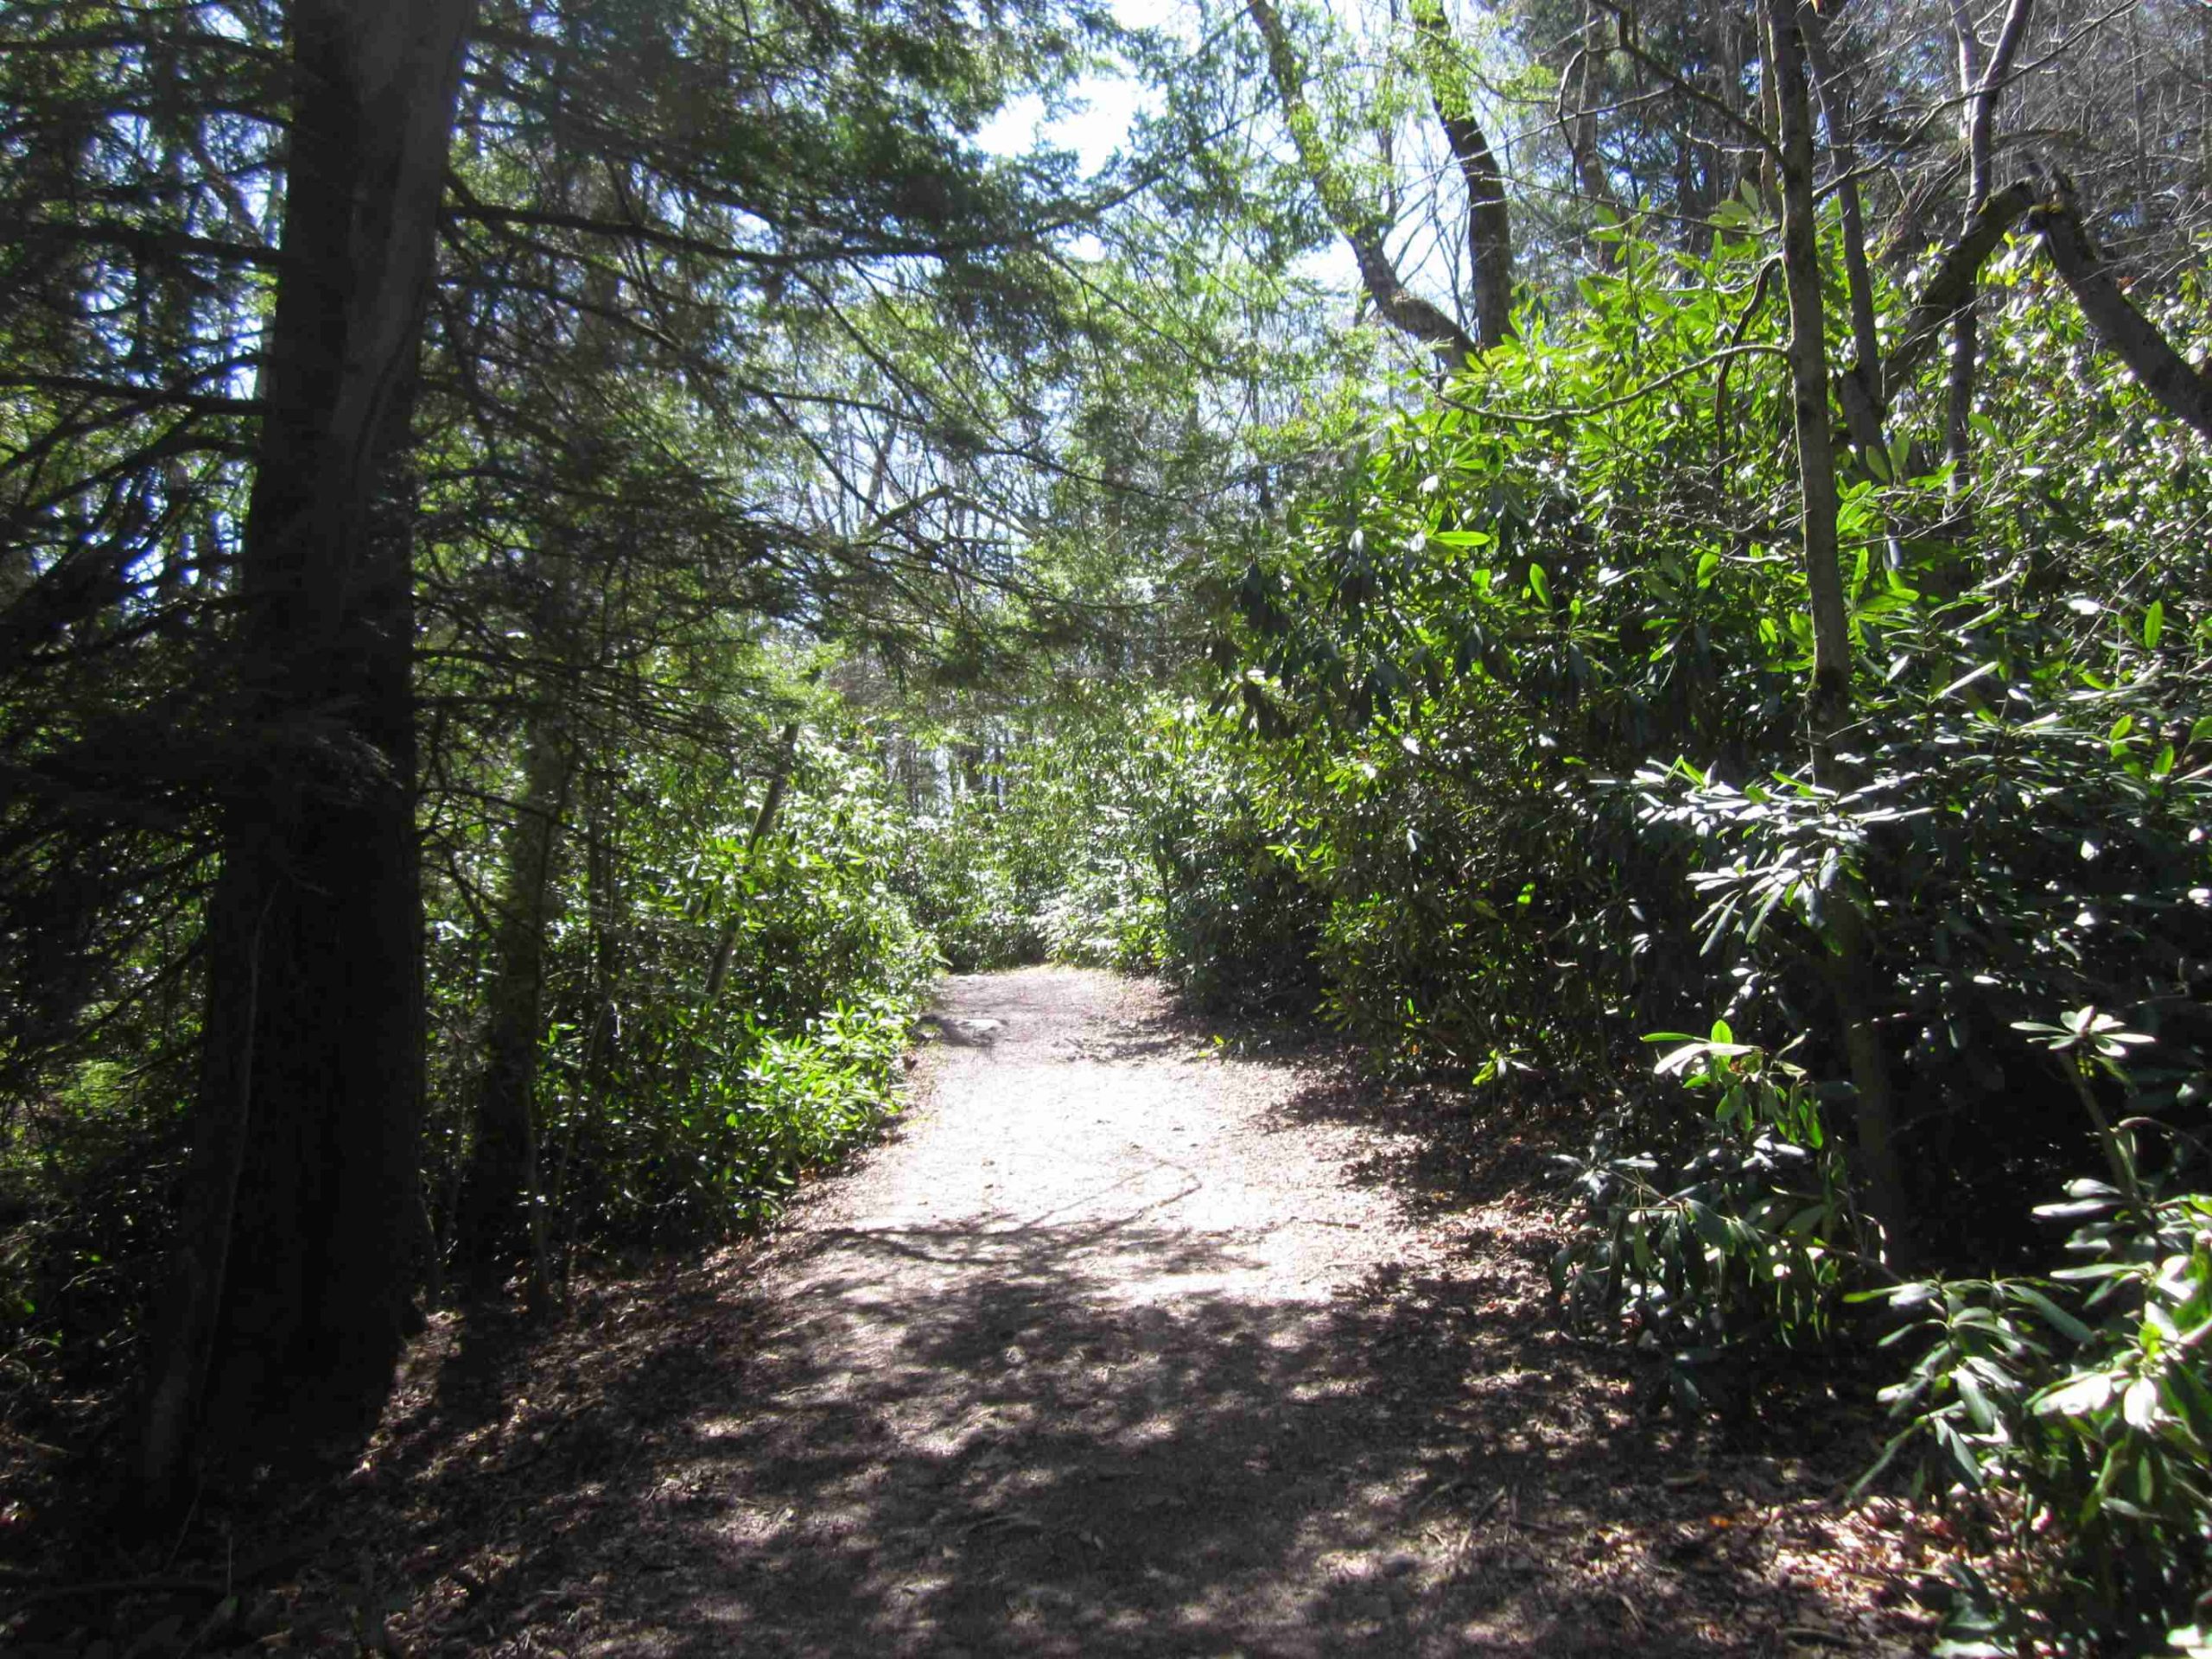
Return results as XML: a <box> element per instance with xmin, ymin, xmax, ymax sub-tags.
<box><xmin>20</xmin><ymin>969</ymin><xmax>1933</xmax><ymax>1659</ymax></box>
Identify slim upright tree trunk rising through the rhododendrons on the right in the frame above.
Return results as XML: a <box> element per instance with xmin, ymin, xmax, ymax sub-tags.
<box><xmin>1763</xmin><ymin>0</ymin><xmax>1909</xmax><ymax>1252</ymax></box>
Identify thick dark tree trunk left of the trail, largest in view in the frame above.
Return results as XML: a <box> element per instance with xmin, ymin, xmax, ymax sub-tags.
<box><xmin>139</xmin><ymin>0</ymin><xmax>474</xmax><ymax>1497</ymax></box>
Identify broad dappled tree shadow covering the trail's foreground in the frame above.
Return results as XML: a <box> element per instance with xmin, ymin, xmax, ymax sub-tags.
<box><xmin>372</xmin><ymin>1224</ymin><xmax>1875</xmax><ymax>1656</ymax></box>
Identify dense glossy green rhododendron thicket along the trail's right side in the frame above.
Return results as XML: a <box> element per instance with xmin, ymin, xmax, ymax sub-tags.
<box><xmin>849</xmin><ymin>237</ymin><xmax>2212</xmax><ymax>1650</ymax></box>
